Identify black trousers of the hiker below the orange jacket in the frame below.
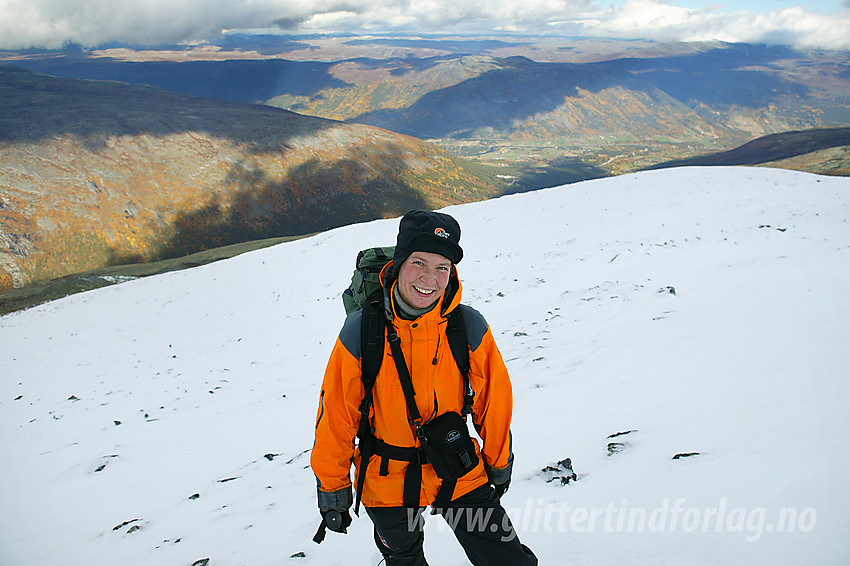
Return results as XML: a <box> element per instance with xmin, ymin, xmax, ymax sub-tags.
<box><xmin>366</xmin><ymin>484</ymin><xmax>537</xmax><ymax>566</ymax></box>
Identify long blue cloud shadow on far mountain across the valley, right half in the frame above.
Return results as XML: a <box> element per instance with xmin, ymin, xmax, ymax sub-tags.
<box><xmin>350</xmin><ymin>47</ymin><xmax>807</xmax><ymax>139</ymax></box>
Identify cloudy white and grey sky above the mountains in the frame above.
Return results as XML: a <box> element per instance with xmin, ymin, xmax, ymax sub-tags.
<box><xmin>0</xmin><ymin>0</ymin><xmax>850</xmax><ymax>49</ymax></box>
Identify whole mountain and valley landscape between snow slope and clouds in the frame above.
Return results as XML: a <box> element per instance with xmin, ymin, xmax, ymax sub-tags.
<box><xmin>0</xmin><ymin>36</ymin><xmax>850</xmax><ymax>292</ymax></box>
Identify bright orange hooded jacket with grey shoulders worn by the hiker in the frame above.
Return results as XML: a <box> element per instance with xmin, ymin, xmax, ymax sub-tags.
<box><xmin>310</xmin><ymin>268</ymin><xmax>513</xmax><ymax>507</ymax></box>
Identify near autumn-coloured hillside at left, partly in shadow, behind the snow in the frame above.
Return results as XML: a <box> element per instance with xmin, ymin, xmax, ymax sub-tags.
<box><xmin>0</xmin><ymin>67</ymin><xmax>503</xmax><ymax>292</ymax></box>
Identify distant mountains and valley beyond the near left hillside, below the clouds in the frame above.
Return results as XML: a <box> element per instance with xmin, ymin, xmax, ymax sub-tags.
<box><xmin>8</xmin><ymin>35</ymin><xmax>850</xmax><ymax>176</ymax></box>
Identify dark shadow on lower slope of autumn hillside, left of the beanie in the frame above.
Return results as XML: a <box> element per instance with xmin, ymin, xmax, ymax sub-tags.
<box><xmin>108</xmin><ymin>152</ymin><xmax>428</xmax><ymax>265</ymax></box>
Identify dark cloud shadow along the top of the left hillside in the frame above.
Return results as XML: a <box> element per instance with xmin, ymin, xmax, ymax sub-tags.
<box><xmin>0</xmin><ymin>67</ymin><xmax>338</xmax><ymax>153</ymax></box>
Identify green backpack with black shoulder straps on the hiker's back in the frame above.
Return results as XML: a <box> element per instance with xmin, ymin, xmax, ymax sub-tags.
<box><xmin>342</xmin><ymin>246</ymin><xmax>475</xmax><ymax>515</ymax></box>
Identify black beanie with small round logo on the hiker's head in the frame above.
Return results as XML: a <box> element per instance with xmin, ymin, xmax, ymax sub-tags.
<box><xmin>393</xmin><ymin>210</ymin><xmax>463</xmax><ymax>269</ymax></box>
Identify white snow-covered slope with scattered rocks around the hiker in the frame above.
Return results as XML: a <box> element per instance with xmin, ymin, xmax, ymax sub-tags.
<box><xmin>0</xmin><ymin>168</ymin><xmax>850</xmax><ymax>566</ymax></box>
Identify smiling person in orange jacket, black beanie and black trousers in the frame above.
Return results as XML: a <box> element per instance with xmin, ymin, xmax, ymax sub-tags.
<box><xmin>311</xmin><ymin>210</ymin><xmax>537</xmax><ymax>566</ymax></box>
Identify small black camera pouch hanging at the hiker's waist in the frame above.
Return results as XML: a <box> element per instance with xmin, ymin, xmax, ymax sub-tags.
<box><xmin>420</xmin><ymin>413</ymin><xmax>478</xmax><ymax>480</ymax></box>
